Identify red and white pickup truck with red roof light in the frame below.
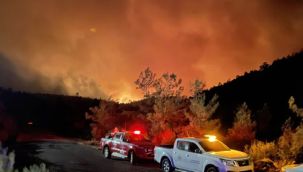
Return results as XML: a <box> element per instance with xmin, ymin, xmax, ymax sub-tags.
<box><xmin>100</xmin><ymin>131</ymin><xmax>155</xmax><ymax>164</ymax></box>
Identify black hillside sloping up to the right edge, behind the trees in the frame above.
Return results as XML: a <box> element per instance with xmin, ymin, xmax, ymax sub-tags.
<box><xmin>208</xmin><ymin>51</ymin><xmax>303</xmax><ymax>139</ymax></box>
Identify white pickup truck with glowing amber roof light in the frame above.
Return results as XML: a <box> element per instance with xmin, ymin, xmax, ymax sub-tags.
<box><xmin>154</xmin><ymin>136</ymin><xmax>254</xmax><ymax>172</ymax></box>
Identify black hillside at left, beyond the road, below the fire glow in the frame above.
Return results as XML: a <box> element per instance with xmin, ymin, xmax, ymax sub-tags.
<box><xmin>0</xmin><ymin>88</ymin><xmax>99</xmax><ymax>138</ymax></box>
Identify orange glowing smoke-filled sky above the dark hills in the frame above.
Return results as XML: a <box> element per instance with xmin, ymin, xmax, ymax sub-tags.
<box><xmin>0</xmin><ymin>0</ymin><xmax>303</xmax><ymax>99</ymax></box>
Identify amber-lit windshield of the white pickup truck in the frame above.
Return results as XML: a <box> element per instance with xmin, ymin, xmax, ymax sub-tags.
<box><xmin>199</xmin><ymin>139</ymin><xmax>230</xmax><ymax>152</ymax></box>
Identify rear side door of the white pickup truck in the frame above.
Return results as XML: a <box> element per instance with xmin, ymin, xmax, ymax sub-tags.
<box><xmin>173</xmin><ymin>140</ymin><xmax>189</xmax><ymax>170</ymax></box>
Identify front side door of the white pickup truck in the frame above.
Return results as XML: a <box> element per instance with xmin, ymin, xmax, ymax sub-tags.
<box><xmin>184</xmin><ymin>142</ymin><xmax>204</xmax><ymax>171</ymax></box>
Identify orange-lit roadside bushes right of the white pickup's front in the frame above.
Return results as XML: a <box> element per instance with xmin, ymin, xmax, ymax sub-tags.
<box><xmin>245</xmin><ymin>97</ymin><xmax>303</xmax><ymax>171</ymax></box>
